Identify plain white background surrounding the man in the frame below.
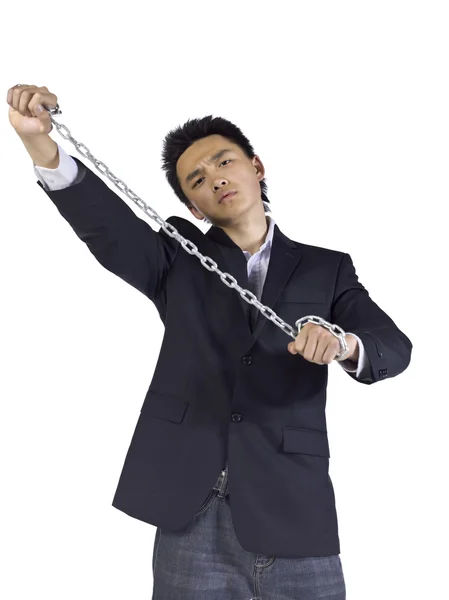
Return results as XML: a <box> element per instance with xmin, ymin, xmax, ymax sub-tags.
<box><xmin>0</xmin><ymin>0</ymin><xmax>449</xmax><ymax>600</ymax></box>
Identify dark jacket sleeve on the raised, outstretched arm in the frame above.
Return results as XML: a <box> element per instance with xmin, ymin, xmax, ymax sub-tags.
<box><xmin>37</xmin><ymin>156</ymin><xmax>180</xmax><ymax>301</ymax></box>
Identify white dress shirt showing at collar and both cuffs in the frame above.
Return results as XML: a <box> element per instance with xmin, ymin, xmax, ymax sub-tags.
<box><xmin>34</xmin><ymin>144</ymin><xmax>370</xmax><ymax>377</ymax></box>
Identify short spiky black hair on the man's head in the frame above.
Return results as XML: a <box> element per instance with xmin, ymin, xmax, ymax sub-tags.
<box><xmin>162</xmin><ymin>115</ymin><xmax>271</xmax><ymax>221</ymax></box>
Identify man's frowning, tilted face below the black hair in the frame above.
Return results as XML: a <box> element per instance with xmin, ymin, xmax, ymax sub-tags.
<box><xmin>176</xmin><ymin>135</ymin><xmax>265</xmax><ymax>227</ymax></box>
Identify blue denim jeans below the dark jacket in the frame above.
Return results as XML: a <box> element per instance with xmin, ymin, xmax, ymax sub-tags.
<box><xmin>152</xmin><ymin>468</ymin><xmax>346</xmax><ymax>600</ymax></box>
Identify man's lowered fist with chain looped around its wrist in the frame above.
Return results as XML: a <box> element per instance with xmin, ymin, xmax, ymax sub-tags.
<box><xmin>288</xmin><ymin>323</ymin><xmax>359</xmax><ymax>365</ymax></box>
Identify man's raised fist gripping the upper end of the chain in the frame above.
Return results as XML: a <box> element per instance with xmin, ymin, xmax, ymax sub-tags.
<box><xmin>6</xmin><ymin>85</ymin><xmax>58</xmax><ymax>138</ymax></box>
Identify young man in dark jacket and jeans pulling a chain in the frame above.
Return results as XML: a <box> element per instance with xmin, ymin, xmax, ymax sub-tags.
<box><xmin>9</xmin><ymin>84</ymin><xmax>412</xmax><ymax>600</ymax></box>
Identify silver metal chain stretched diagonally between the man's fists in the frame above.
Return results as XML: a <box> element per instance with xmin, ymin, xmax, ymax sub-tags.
<box><xmin>44</xmin><ymin>104</ymin><xmax>349</xmax><ymax>361</ymax></box>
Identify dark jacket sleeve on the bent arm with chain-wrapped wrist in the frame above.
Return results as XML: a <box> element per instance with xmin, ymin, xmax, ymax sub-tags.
<box><xmin>331</xmin><ymin>254</ymin><xmax>413</xmax><ymax>384</ymax></box>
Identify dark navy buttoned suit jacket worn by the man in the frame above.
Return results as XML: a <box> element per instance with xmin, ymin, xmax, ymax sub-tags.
<box><xmin>38</xmin><ymin>157</ymin><xmax>412</xmax><ymax>557</ymax></box>
